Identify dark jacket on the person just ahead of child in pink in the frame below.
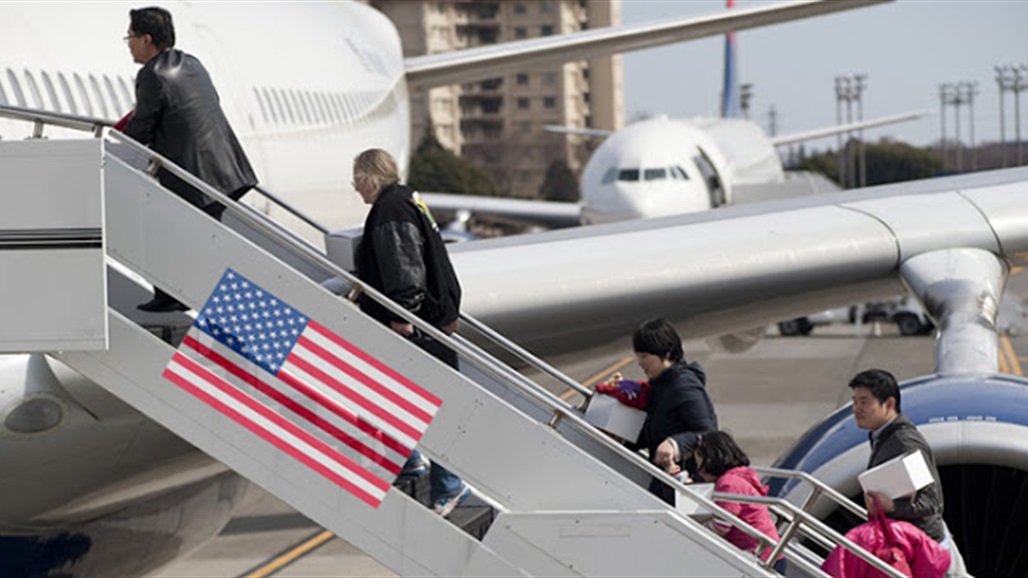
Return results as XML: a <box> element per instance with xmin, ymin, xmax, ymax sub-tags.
<box><xmin>636</xmin><ymin>361</ymin><xmax>718</xmax><ymax>464</ymax></box>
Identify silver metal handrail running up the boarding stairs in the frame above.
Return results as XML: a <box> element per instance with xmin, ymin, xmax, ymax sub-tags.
<box><xmin>6</xmin><ymin>106</ymin><xmax>888</xmax><ymax>574</ymax></box>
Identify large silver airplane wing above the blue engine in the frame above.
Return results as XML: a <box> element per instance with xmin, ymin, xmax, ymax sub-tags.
<box><xmin>451</xmin><ymin>168</ymin><xmax>1028</xmax><ymax>356</ymax></box>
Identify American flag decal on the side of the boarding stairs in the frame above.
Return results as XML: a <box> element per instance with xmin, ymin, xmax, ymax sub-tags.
<box><xmin>162</xmin><ymin>268</ymin><xmax>442</xmax><ymax>508</ymax></box>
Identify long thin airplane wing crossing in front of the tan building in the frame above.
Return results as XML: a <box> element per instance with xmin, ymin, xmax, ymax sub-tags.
<box><xmin>404</xmin><ymin>0</ymin><xmax>891</xmax><ymax>88</ymax></box>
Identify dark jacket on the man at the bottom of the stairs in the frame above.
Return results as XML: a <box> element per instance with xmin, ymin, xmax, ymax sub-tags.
<box><xmin>868</xmin><ymin>414</ymin><xmax>945</xmax><ymax>542</ymax></box>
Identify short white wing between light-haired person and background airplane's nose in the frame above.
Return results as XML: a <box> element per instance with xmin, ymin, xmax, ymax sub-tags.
<box><xmin>420</xmin><ymin>192</ymin><xmax>582</xmax><ymax>228</ymax></box>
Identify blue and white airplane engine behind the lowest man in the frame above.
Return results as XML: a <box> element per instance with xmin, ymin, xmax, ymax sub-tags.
<box><xmin>771</xmin><ymin>375</ymin><xmax>1028</xmax><ymax>576</ymax></box>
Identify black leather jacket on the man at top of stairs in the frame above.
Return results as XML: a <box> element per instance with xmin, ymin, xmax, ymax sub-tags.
<box><xmin>124</xmin><ymin>48</ymin><xmax>257</xmax><ymax>208</ymax></box>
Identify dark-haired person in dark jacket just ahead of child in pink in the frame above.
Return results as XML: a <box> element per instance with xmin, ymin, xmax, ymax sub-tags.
<box><xmin>630</xmin><ymin>319</ymin><xmax>718</xmax><ymax>504</ymax></box>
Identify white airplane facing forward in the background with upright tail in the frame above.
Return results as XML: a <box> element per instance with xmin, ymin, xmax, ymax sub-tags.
<box><xmin>425</xmin><ymin>0</ymin><xmax>930</xmax><ymax>227</ymax></box>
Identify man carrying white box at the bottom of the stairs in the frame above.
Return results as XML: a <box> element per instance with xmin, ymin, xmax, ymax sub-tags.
<box><xmin>849</xmin><ymin>369</ymin><xmax>968</xmax><ymax>577</ymax></box>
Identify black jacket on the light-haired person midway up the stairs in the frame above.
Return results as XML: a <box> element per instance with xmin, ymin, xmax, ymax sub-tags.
<box><xmin>357</xmin><ymin>183</ymin><xmax>461</xmax><ymax>327</ymax></box>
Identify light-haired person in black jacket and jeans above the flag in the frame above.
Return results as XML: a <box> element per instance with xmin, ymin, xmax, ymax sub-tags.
<box><xmin>354</xmin><ymin>148</ymin><xmax>471</xmax><ymax>516</ymax></box>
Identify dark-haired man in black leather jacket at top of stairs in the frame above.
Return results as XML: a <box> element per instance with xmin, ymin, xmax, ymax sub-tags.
<box><xmin>124</xmin><ymin>7</ymin><xmax>257</xmax><ymax>312</ymax></box>
